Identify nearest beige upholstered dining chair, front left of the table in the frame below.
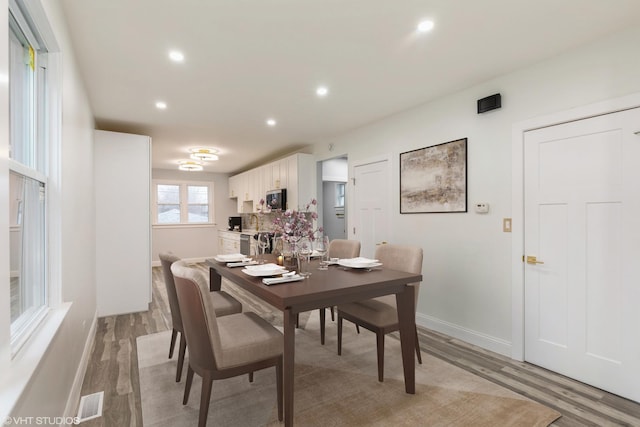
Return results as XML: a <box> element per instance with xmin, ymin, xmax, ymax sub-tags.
<box><xmin>171</xmin><ymin>262</ymin><xmax>284</xmax><ymax>427</ymax></box>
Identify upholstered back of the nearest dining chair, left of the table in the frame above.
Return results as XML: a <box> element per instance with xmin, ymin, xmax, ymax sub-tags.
<box><xmin>171</xmin><ymin>261</ymin><xmax>222</xmax><ymax>371</ymax></box>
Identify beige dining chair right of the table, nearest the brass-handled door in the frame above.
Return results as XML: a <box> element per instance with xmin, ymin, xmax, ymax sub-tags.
<box><xmin>338</xmin><ymin>244</ymin><xmax>422</xmax><ymax>382</ymax></box>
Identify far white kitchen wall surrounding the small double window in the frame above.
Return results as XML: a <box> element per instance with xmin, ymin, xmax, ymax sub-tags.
<box><xmin>151</xmin><ymin>169</ymin><xmax>237</xmax><ymax>265</ymax></box>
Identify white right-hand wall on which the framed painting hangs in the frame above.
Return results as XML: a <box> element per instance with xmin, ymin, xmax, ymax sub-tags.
<box><xmin>314</xmin><ymin>27</ymin><xmax>640</xmax><ymax>355</ymax></box>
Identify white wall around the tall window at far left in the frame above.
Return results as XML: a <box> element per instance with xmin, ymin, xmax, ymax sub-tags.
<box><xmin>0</xmin><ymin>2</ymin><xmax>96</xmax><ymax>422</ymax></box>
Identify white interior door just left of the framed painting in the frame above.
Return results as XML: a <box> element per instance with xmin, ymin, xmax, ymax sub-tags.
<box><xmin>349</xmin><ymin>159</ymin><xmax>390</xmax><ymax>258</ymax></box>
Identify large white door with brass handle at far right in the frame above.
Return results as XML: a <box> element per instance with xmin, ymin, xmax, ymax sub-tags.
<box><xmin>524</xmin><ymin>109</ymin><xmax>640</xmax><ymax>401</ymax></box>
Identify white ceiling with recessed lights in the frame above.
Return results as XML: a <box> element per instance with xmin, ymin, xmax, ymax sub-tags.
<box><xmin>62</xmin><ymin>0</ymin><xmax>640</xmax><ymax>173</ymax></box>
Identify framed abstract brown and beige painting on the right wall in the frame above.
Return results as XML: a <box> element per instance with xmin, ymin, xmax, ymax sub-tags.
<box><xmin>400</xmin><ymin>138</ymin><xmax>467</xmax><ymax>214</ymax></box>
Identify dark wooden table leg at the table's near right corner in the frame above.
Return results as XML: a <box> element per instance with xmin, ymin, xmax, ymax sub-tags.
<box><xmin>396</xmin><ymin>286</ymin><xmax>416</xmax><ymax>394</ymax></box>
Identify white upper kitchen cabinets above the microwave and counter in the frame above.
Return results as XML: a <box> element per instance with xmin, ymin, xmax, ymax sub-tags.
<box><xmin>229</xmin><ymin>153</ymin><xmax>315</xmax><ymax>213</ymax></box>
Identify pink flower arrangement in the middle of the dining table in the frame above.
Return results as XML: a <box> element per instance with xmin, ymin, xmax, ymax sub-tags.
<box><xmin>260</xmin><ymin>199</ymin><xmax>323</xmax><ymax>243</ymax></box>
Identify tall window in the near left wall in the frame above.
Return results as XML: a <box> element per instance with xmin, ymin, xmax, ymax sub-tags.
<box><xmin>9</xmin><ymin>1</ymin><xmax>50</xmax><ymax>353</ymax></box>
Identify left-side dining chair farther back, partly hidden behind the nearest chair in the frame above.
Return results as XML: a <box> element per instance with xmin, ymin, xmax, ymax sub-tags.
<box><xmin>158</xmin><ymin>253</ymin><xmax>242</xmax><ymax>382</ymax></box>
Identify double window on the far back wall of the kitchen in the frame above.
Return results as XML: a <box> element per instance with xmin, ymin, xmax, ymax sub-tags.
<box><xmin>154</xmin><ymin>182</ymin><xmax>213</xmax><ymax>225</ymax></box>
